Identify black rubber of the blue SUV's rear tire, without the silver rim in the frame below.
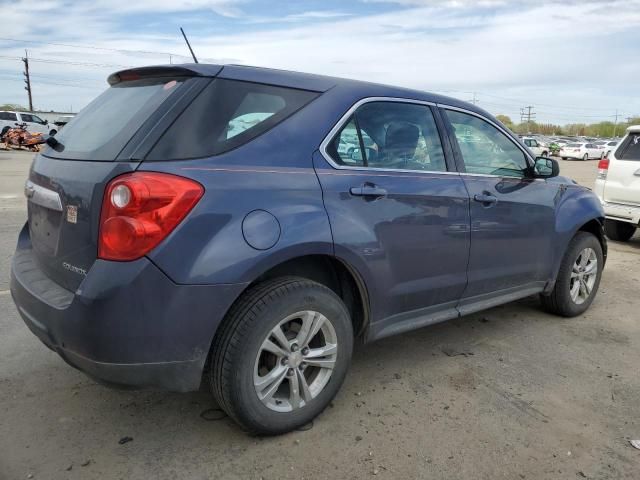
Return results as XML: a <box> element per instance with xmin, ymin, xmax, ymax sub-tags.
<box><xmin>210</xmin><ymin>277</ymin><xmax>353</xmax><ymax>435</ymax></box>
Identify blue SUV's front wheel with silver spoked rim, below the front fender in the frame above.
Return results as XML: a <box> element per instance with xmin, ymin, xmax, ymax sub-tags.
<box><xmin>540</xmin><ymin>232</ymin><xmax>604</xmax><ymax>317</ymax></box>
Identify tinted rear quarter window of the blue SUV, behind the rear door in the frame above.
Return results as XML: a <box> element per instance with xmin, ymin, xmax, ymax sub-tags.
<box><xmin>148</xmin><ymin>79</ymin><xmax>319</xmax><ymax>160</ymax></box>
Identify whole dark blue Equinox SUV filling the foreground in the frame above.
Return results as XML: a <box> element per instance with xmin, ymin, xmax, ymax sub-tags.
<box><xmin>11</xmin><ymin>64</ymin><xmax>607</xmax><ymax>434</ymax></box>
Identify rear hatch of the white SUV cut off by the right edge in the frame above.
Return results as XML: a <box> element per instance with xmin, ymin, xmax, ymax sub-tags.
<box><xmin>604</xmin><ymin>126</ymin><xmax>640</xmax><ymax>205</ymax></box>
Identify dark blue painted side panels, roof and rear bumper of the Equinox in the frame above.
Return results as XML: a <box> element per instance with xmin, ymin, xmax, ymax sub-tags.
<box><xmin>11</xmin><ymin>65</ymin><xmax>604</xmax><ymax>391</ymax></box>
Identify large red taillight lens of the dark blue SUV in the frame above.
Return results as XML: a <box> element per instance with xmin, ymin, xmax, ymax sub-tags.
<box><xmin>98</xmin><ymin>172</ymin><xmax>204</xmax><ymax>261</ymax></box>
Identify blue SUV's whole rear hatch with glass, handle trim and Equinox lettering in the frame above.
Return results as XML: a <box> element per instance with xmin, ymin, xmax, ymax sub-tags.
<box><xmin>25</xmin><ymin>66</ymin><xmax>220</xmax><ymax>291</ymax></box>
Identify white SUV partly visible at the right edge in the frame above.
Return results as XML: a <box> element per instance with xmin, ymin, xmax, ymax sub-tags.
<box><xmin>594</xmin><ymin>125</ymin><xmax>640</xmax><ymax>242</ymax></box>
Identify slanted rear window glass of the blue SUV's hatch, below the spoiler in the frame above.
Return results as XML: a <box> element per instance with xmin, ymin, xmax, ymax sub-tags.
<box><xmin>44</xmin><ymin>77</ymin><xmax>185</xmax><ymax>161</ymax></box>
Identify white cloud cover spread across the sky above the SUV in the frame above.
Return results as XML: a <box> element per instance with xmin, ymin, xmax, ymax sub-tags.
<box><xmin>0</xmin><ymin>0</ymin><xmax>640</xmax><ymax>123</ymax></box>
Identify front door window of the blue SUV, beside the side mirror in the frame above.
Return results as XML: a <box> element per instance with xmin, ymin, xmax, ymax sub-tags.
<box><xmin>446</xmin><ymin>110</ymin><xmax>529</xmax><ymax>177</ymax></box>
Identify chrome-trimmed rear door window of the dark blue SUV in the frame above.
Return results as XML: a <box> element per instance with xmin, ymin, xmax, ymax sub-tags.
<box><xmin>327</xmin><ymin>102</ymin><xmax>447</xmax><ymax>172</ymax></box>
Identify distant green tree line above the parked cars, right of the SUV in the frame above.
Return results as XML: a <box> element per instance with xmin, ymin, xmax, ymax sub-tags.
<box><xmin>496</xmin><ymin>115</ymin><xmax>640</xmax><ymax>138</ymax></box>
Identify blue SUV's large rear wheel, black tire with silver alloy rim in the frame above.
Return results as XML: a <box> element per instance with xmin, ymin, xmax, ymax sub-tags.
<box><xmin>211</xmin><ymin>277</ymin><xmax>353</xmax><ymax>435</ymax></box>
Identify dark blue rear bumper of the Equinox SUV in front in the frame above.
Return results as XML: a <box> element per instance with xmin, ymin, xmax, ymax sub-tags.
<box><xmin>11</xmin><ymin>223</ymin><xmax>246</xmax><ymax>391</ymax></box>
